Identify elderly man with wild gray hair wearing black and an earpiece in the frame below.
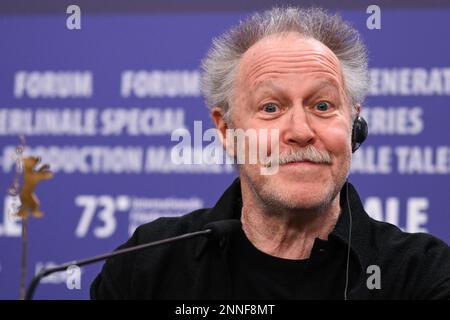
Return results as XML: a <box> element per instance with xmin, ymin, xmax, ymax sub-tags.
<box><xmin>91</xmin><ymin>8</ymin><xmax>450</xmax><ymax>299</ymax></box>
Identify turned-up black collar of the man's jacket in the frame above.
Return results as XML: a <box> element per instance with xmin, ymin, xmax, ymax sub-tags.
<box><xmin>195</xmin><ymin>178</ymin><xmax>372</xmax><ymax>270</ymax></box>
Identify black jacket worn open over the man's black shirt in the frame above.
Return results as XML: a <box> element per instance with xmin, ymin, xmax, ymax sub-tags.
<box><xmin>91</xmin><ymin>179</ymin><xmax>450</xmax><ymax>299</ymax></box>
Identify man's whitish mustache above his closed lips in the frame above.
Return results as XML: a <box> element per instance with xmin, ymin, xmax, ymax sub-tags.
<box><xmin>268</xmin><ymin>145</ymin><xmax>332</xmax><ymax>166</ymax></box>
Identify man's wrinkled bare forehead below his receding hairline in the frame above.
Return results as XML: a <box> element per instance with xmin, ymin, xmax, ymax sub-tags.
<box><xmin>236</xmin><ymin>32</ymin><xmax>344</xmax><ymax>88</ymax></box>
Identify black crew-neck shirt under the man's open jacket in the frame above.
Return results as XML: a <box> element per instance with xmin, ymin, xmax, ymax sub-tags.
<box><xmin>230</xmin><ymin>230</ymin><xmax>307</xmax><ymax>299</ymax></box>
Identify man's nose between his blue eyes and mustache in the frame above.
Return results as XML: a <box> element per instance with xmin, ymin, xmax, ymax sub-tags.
<box><xmin>280</xmin><ymin>105</ymin><xmax>315</xmax><ymax>146</ymax></box>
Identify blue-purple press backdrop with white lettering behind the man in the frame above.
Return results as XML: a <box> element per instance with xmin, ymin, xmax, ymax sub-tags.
<box><xmin>0</xmin><ymin>1</ymin><xmax>450</xmax><ymax>299</ymax></box>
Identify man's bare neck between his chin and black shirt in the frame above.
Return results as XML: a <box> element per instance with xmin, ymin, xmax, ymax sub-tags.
<box><xmin>241</xmin><ymin>188</ymin><xmax>341</xmax><ymax>260</ymax></box>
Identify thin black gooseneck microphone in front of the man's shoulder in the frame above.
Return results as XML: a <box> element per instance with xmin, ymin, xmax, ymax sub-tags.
<box><xmin>25</xmin><ymin>219</ymin><xmax>241</xmax><ymax>300</ymax></box>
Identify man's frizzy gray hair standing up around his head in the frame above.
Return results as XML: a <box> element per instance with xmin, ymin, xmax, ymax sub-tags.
<box><xmin>201</xmin><ymin>7</ymin><xmax>369</xmax><ymax>121</ymax></box>
